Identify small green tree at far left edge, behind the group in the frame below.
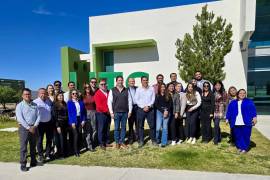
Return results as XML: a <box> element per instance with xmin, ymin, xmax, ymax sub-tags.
<box><xmin>0</xmin><ymin>86</ymin><xmax>20</xmax><ymax>109</ymax></box>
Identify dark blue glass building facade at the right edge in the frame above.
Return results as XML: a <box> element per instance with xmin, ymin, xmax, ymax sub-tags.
<box><xmin>247</xmin><ymin>0</ymin><xmax>270</xmax><ymax>114</ymax></box>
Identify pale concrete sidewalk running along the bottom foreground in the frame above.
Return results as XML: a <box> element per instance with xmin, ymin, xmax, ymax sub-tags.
<box><xmin>0</xmin><ymin>163</ymin><xmax>270</xmax><ymax>180</ymax></box>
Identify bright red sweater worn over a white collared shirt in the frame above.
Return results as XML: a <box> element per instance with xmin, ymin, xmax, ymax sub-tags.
<box><xmin>94</xmin><ymin>89</ymin><xmax>109</xmax><ymax>113</ymax></box>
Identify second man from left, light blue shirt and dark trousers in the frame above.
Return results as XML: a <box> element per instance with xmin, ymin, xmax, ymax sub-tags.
<box><xmin>34</xmin><ymin>88</ymin><xmax>53</xmax><ymax>163</ymax></box>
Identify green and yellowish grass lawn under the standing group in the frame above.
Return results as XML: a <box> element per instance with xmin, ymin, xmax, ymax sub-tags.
<box><xmin>0</xmin><ymin>119</ymin><xmax>270</xmax><ymax>175</ymax></box>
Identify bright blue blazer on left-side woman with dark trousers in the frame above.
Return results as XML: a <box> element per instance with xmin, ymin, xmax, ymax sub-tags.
<box><xmin>67</xmin><ymin>100</ymin><xmax>86</xmax><ymax>125</ymax></box>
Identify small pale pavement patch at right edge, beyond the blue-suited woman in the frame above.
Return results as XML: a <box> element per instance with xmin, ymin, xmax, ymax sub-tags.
<box><xmin>255</xmin><ymin>115</ymin><xmax>270</xmax><ymax>140</ymax></box>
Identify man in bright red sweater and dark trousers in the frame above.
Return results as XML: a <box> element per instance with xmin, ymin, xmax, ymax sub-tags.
<box><xmin>94</xmin><ymin>79</ymin><xmax>111</xmax><ymax>150</ymax></box>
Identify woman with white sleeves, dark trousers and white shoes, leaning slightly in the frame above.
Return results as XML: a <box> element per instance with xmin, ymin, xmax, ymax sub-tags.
<box><xmin>185</xmin><ymin>83</ymin><xmax>201</xmax><ymax>144</ymax></box>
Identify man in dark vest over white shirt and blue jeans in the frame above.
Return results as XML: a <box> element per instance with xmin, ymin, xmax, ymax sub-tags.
<box><xmin>108</xmin><ymin>76</ymin><xmax>132</xmax><ymax>149</ymax></box>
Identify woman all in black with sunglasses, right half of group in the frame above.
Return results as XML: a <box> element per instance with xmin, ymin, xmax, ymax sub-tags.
<box><xmin>200</xmin><ymin>81</ymin><xmax>215</xmax><ymax>143</ymax></box>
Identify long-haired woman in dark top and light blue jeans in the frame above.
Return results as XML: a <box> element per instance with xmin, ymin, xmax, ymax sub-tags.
<box><xmin>154</xmin><ymin>83</ymin><xmax>172</xmax><ymax>147</ymax></box>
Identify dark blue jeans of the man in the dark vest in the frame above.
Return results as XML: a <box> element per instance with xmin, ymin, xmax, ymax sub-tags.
<box><xmin>114</xmin><ymin>112</ymin><xmax>128</xmax><ymax>144</ymax></box>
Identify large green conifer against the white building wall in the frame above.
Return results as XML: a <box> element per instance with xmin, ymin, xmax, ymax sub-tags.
<box><xmin>175</xmin><ymin>5</ymin><xmax>233</xmax><ymax>82</ymax></box>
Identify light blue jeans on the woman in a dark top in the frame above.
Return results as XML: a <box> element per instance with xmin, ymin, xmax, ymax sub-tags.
<box><xmin>156</xmin><ymin>110</ymin><xmax>170</xmax><ymax>145</ymax></box>
